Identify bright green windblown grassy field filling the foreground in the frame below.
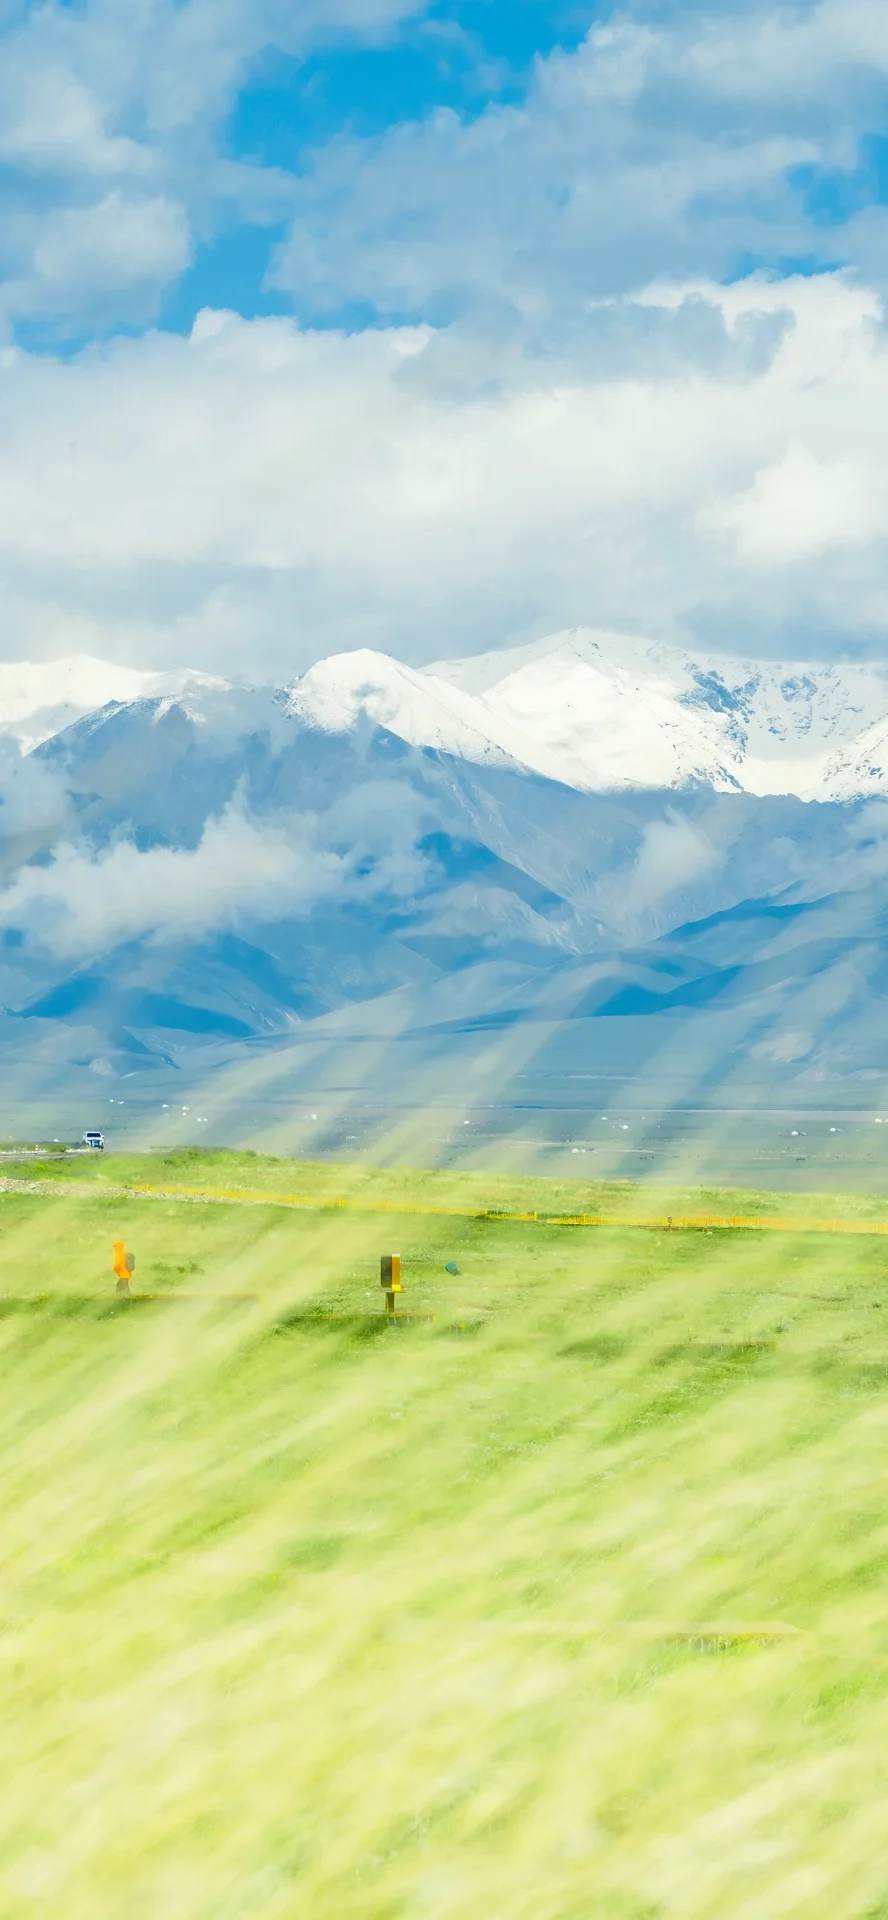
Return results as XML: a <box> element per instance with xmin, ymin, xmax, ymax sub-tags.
<box><xmin>0</xmin><ymin>1154</ymin><xmax>888</xmax><ymax>1920</ymax></box>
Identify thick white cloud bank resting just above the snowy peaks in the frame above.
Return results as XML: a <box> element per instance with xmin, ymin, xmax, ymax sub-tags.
<box><xmin>0</xmin><ymin>275</ymin><xmax>888</xmax><ymax>676</ymax></box>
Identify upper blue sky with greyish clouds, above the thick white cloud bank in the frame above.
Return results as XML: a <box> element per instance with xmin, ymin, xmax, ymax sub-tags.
<box><xmin>0</xmin><ymin>0</ymin><xmax>888</xmax><ymax>351</ymax></box>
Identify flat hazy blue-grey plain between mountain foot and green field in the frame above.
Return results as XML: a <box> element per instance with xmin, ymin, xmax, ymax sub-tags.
<box><xmin>8</xmin><ymin>1105</ymin><xmax>888</xmax><ymax>1196</ymax></box>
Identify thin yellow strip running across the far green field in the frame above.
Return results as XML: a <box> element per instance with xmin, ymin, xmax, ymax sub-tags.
<box><xmin>127</xmin><ymin>1185</ymin><xmax>888</xmax><ymax>1235</ymax></box>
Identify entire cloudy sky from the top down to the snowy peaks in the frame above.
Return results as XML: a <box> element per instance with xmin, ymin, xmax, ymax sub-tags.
<box><xmin>0</xmin><ymin>0</ymin><xmax>888</xmax><ymax>672</ymax></box>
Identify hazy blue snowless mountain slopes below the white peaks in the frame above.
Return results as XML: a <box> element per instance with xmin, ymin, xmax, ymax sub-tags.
<box><xmin>0</xmin><ymin>689</ymin><xmax>888</xmax><ymax>1128</ymax></box>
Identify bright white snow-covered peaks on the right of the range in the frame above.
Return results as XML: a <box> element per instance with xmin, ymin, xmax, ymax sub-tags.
<box><xmin>290</xmin><ymin>628</ymin><xmax>888</xmax><ymax>801</ymax></box>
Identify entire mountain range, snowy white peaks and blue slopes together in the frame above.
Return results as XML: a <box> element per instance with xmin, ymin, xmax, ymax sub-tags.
<box><xmin>0</xmin><ymin>632</ymin><xmax>888</xmax><ymax>1150</ymax></box>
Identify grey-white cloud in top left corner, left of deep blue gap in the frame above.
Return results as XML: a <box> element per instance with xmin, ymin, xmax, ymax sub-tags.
<box><xmin>0</xmin><ymin>0</ymin><xmax>427</xmax><ymax>332</ymax></box>
